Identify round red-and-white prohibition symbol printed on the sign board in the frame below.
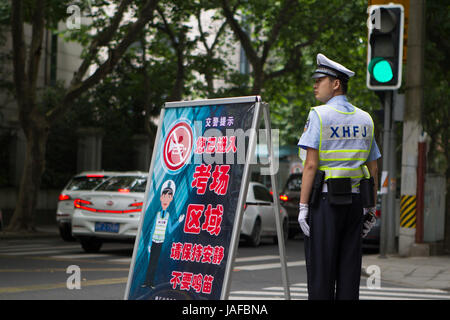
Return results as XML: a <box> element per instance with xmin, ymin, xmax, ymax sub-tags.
<box><xmin>163</xmin><ymin>122</ymin><xmax>194</xmax><ymax>170</ymax></box>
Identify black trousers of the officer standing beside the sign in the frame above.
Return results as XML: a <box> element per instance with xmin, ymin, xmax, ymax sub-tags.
<box><xmin>305</xmin><ymin>193</ymin><xmax>363</xmax><ymax>300</ymax></box>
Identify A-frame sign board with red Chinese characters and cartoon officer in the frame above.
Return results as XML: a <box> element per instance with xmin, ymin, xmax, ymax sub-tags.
<box><xmin>125</xmin><ymin>96</ymin><xmax>290</xmax><ymax>300</ymax></box>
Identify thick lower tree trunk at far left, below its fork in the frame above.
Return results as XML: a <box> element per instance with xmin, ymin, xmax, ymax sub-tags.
<box><xmin>7</xmin><ymin>112</ymin><xmax>48</xmax><ymax>231</ymax></box>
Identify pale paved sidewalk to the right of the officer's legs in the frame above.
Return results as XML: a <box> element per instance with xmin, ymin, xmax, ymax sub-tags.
<box><xmin>362</xmin><ymin>254</ymin><xmax>450</xmax><ymax>291</ymax></box>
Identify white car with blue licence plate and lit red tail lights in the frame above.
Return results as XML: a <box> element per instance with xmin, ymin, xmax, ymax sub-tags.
<box><xmin>72</xmin><ymin>172</ymin><xmax>148</xmax><ymax>252</ymax></box>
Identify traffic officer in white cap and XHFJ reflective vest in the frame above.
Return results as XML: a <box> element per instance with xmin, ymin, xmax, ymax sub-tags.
<box><xmin>298</xmin><ymin>53</ymin><xmax>381</xmax><ymax>300</ymax></box>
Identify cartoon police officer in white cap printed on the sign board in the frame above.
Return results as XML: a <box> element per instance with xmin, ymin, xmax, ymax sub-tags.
<box><xmin>141</xmin><ymin>180</ymin><xmax>184</xmax><ymax>289</ymax></box>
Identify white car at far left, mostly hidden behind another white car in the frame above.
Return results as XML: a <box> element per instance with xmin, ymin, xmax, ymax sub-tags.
<box><xmin>56</xmin><ymin>171</ymin><xmax>116</xmax><ymax>241</ymax></box>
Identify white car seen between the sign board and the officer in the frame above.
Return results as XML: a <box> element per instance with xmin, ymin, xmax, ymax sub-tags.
<box><xmin>241</xmin><ymin>182</ymin><xmax>289</xmax><ymax>247</ymax></box>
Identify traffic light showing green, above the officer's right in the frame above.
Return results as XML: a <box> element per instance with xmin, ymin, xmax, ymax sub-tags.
<box><xmin>367</xmin><ymin>4</ymin><xmax>404</xmax><ymax>90</ymax></box>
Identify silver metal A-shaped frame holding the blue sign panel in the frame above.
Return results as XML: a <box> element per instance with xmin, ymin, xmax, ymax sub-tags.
<box><xmin>124</xmin><ymin>96</ymin><xmax>290</xmax><ymax>300</ymax></box>
